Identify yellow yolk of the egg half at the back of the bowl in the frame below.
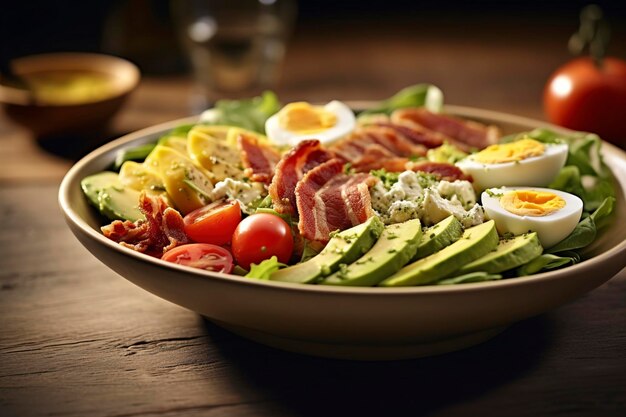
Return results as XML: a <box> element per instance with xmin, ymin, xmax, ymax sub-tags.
<box><xmin>278</xmin><ymin>102</ymin><xmax>337</xmax><ymax>133</ymax></box>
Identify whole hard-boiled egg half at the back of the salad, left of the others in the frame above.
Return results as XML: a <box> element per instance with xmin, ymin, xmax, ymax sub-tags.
<box><xmin>265</xmin><ymin>100</ymin><xmax>356</xmax><ymax>146</ymax></box>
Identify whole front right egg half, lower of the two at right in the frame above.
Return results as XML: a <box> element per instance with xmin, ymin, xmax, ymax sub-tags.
<box><xmin>481</xmin><ymin>187</ymin><xmax>583</xmax><ymax>248</ymax></box>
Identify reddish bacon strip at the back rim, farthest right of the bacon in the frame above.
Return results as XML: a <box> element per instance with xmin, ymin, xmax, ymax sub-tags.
<box><xmin>391</xmin><ymin>108</ymin><xmax>500</xmax><ymax>151</ymax></box>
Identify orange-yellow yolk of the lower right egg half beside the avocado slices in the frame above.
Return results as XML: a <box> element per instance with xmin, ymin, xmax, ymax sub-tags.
<box><xmin>500</xmin><ymin>190</ymin><xmax>565</xmax><ymax>217</ymax></box>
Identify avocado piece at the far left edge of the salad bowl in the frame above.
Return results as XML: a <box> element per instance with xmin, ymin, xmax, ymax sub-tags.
<box><xmin>80</xmin><ymin>171</ymin><xmax>145</xmax><ymax>222</ymax></box>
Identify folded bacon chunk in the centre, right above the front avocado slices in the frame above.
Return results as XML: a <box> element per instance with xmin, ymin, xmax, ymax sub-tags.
<box><xmin>295</xmin><ymin>158</ymin><xmax>377</xmax><ymax>242</ymax></box>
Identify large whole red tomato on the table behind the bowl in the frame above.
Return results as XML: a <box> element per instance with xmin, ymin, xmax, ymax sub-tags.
<box><xmin>543</xmin><ymin>57</ymin><xmax>626</xmax><ymax>144</ymax></box>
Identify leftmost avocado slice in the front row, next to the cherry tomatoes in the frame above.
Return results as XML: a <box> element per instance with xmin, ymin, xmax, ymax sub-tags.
<box><xmin>270</xmin><ymin>216</ymin><xmax>385</xmax><ymax>284</ymax></box>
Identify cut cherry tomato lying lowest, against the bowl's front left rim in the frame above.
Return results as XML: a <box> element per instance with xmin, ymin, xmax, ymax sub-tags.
<box><xmin>161</xmin><ymin>243</ymin><xmax>233</xmax><ymax>274</ymax></box>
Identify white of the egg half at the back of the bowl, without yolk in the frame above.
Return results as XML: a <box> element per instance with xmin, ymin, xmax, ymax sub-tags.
<box><xmin>265</xmin><ymin>100</ymin><xmax>356</xmax><ymax>146</ymax></box>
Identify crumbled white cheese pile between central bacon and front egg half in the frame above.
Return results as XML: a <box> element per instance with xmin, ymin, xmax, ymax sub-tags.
<box><xmin>370</xmin><ymin>171</ymin><xmax>485</xmax><ymax>227</ymax></box>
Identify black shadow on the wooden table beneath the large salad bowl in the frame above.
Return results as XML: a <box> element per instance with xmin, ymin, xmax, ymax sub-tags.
<box><xmin>203</xmin><ymin>315</ymin><xmax>558</xmax><ymax>417</ymax></box>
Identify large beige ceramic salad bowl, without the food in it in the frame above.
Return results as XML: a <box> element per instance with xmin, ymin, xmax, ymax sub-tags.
<box><xmin>59</xmin><ymin>106</ymin><xmax>626</xmax><ymax>360</ymax></box>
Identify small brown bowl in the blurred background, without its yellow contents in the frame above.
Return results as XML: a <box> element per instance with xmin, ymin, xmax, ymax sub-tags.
<box><xmin>0</xmin><ymin>53</ymin><xmax>141</xmax><ymax>137</ymax></box>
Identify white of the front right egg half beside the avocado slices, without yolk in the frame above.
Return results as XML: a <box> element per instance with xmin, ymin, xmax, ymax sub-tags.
<box><xmin>481</xmin><ymin>187</ymin><xmax>583</xmax><ymax>249</ymax></box>
